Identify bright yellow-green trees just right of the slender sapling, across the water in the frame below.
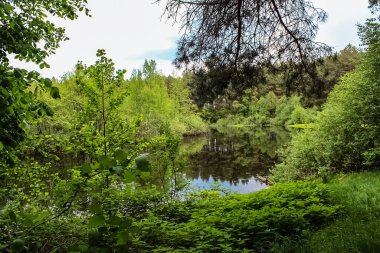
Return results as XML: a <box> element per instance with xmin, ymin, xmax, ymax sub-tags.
<box><xmin>123</xmin><ymin>61</ymin><xmax>207</xmax><ymax>138</ymax></box>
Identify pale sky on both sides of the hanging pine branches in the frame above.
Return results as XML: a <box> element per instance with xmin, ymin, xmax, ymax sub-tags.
<box><xmin>12</xmin><ymin>0</ymin><xmax>370</xmax><ymax>77</ymax></box>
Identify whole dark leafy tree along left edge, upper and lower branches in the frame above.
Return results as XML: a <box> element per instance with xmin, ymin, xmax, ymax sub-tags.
<box><xmin>0</xmin><ymin>0</ymin><xmax>89</xmax><ymax>156</ymax></box>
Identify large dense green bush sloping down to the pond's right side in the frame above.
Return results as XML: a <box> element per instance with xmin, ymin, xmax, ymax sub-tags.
<box><xmin>272</xmin><ymin>20</ymin><xmax>380</xmax><ymax>181</ymax></box>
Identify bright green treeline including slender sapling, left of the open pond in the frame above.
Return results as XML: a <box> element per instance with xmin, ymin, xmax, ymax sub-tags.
<box><xmin>24</xmin><ymin>51</ymin><xmax>208</xmax><ymax>162</ymax></box>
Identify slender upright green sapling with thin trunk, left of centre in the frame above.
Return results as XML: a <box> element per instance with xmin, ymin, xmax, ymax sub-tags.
<box><xmin>76</xmin><ymin>49</ymin><xmax>127</xmax><ymax>156</ymax></box>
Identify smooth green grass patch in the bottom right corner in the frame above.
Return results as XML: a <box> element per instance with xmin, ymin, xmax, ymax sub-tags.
<box><xmin>274</xmin><ymin>172</ymin><xmax>380</xmax><ymax>253</ymax></box>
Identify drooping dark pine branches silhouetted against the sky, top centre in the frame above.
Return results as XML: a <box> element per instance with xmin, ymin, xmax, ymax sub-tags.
<box><xmin>157</xmin><ymin>0</ymin><xmax>330</xmax><ymax>69</ymax></box>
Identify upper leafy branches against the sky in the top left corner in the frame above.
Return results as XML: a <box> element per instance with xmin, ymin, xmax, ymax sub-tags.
<box><xmin>0</xmin><ymin>0</ymin><xmax>89</xmax><ymax>67</ymax></box>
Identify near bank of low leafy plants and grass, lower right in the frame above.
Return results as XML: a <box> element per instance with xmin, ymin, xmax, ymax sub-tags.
<box><xmin>156</xmin><ymin>172</ymin><xmax>380</xmax><ymax>253</ymax></box>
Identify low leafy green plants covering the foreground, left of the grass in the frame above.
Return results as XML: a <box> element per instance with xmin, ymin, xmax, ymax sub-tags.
<box><xmin>0</xmin><ymin>179</ymin><xmax>340</xmax><ymax>252</ymax></box>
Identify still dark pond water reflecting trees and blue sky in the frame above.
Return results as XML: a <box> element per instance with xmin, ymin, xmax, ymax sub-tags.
<box><xmin>180</xmin><ymin>128</ymin><xmax>290</xmax><ymax>193</ymax></box>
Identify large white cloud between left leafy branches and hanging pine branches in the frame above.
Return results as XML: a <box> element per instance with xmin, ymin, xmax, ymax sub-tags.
<box><xmin>10</xmin><ymin>0</ymin><xmax>179</xmax><ymax>77</ymax></box>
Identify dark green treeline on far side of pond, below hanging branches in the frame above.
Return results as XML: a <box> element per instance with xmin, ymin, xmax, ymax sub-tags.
<box><xmin>191</xmin><ymin>45</ymin><xmax>362</xmax><ymax>122</ymax></box>
